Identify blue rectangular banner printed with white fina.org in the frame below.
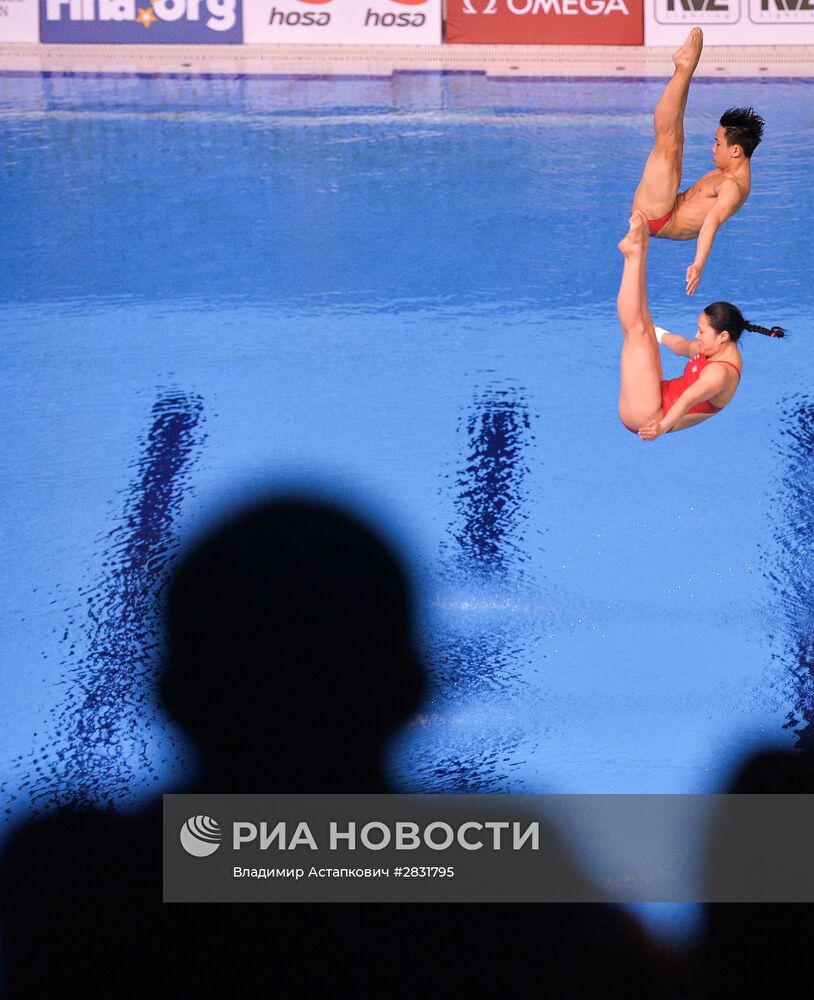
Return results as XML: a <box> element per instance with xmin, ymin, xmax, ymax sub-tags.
<box><xmin>40</xmin><ymin>0</ymin><xmax>243</xmax><ymax>45</ymax></box>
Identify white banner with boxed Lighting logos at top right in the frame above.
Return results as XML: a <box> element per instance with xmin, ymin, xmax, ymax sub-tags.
<box><xmin>644</xmin><ymin>0</ymin><xmax>814</xmax><ymax>46</ymax></box>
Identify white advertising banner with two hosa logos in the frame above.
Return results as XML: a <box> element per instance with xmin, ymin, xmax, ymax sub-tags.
<box><xmin>244</xmin><ymin>0</ymin><xmax>441</xmax><ymax>45</ymax></box>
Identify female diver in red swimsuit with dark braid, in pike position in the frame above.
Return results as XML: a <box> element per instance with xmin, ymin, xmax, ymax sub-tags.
<box><xmin>616</xmin><ymin>211</ymin><xmax>785</xmax><ymax>441</ymax></box>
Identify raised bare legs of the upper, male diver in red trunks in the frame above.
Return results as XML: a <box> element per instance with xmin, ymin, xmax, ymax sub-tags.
<box><xmin>633</xmin><ymin>28</ymin><xmax>704</xmax><ymax>219</ymax></box>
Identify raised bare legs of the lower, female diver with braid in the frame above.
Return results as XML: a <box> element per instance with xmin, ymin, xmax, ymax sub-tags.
<box><xmin>616</xmin><ymin>211</ymin><xmax>661</xmax><ymax>430</ymax></box>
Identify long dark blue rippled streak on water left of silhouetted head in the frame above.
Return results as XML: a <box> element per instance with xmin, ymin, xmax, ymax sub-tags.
<box><xmin>5</xmin><ymin>390</ymin><xmax>204</xmax><ymax>810</ymax></box>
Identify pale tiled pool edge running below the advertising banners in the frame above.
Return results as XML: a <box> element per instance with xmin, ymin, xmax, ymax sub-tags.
<box><xmin>0</xmin><ymin>43</ymin><xmax>814</xmax><ymax>80</ymax></box>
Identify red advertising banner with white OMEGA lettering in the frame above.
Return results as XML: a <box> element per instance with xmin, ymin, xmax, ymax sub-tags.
<box><xmin>446</xmin><ymin>0</ymin><xmax>644</xmax><ymax>45</ymax></box>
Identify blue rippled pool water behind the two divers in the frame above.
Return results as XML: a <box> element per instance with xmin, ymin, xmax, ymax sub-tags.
<box><xmin>0</xmin><ymin>68</ymin><xmax>814</xmax><ymax>928</ymax></box>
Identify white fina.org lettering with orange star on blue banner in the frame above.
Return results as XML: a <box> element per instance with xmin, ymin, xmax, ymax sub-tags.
<box><xmin>45</xmin><ymin>0</ymin><xmax>237</xmax><ymax>31</ymax></box>
